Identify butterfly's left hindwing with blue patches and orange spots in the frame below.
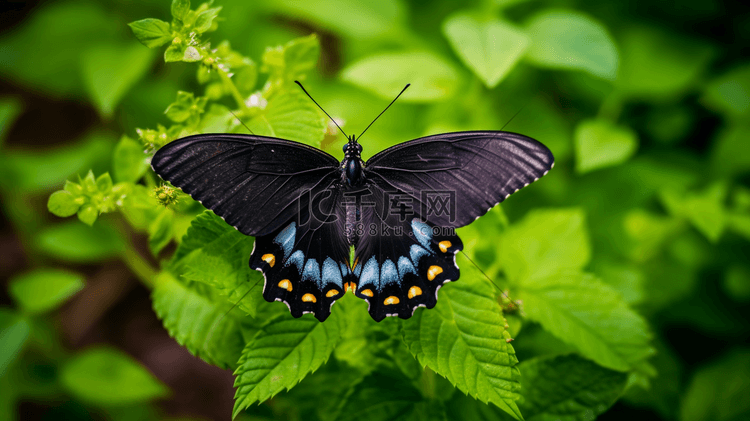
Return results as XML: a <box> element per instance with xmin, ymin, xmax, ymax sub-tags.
<box><xmin>250</xmin><ymin>183</ymin><xmax>355</xmax><ymax>322</ymax></box>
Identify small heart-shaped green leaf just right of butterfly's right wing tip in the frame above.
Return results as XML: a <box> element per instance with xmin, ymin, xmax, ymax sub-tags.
<box><xmin>575</xmin><ymin>119</ymin><xmax>638</xmax><ymax>174</ymax></box>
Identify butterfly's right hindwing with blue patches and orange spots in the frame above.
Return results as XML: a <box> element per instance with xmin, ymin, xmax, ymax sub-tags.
<box><xmin>348</xmin><ymin>184</ymin><xmax>463</xmax><ymax>322</ymax></box>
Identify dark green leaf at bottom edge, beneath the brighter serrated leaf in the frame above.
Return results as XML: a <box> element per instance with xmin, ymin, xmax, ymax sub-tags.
<box><xmin>519</xmin><ymin>354</ymin><xmax>628</xmax><ymax>421</ymax></box>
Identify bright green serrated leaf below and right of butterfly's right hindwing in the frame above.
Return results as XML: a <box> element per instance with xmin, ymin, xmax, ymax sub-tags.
<box><xmin>518</xmin><ymin>271</ymin><xmax>653</xmax><ymax>371</ymax></box>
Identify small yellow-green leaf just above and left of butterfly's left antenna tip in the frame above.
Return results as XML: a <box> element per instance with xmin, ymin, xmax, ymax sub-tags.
<box><xmin>261</xmin><ymin>34</ymin><xmax>320</xmax><ymax>86</ymax></box>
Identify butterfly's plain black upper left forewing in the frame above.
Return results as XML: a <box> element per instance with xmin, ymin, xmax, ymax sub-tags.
<box><xmin>151</xmin><ymin>134</ymin><xmax>339</xmax><ymax>236</ymax></box>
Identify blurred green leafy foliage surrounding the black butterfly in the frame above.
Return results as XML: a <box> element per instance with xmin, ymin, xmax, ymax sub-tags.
<box><xmin>0</xmin><ymin>0</ymin><xmax>750</xmax><ymax>421</ymax></box>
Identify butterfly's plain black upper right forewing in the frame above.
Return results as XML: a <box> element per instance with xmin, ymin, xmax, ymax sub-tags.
<box><xmin>365</xmin><ymin>131</ymin><xmax>554</xmax><ymax>228</ymax></box>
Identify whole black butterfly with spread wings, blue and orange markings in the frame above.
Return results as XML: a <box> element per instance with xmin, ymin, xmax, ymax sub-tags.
<box><xmin>151</xmin><ymin>85</ymin><xmax>554</xmax><ymax>321</ymax></box>
